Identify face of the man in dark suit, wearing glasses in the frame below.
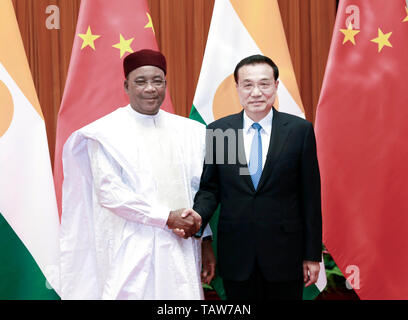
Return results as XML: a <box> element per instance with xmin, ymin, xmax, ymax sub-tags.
<box><xmin>236</xmin><ymin>63</ymin><xmax>279</xmax><ymax>122</ymax></box>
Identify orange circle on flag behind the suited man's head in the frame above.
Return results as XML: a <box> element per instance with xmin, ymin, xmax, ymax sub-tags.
<box><xmin>213</xmin><ymin>74</ymin><xmax>279</xmax><ymax>120</ymax></box>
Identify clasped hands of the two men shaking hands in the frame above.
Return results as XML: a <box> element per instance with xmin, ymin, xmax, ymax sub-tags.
<box><xmin>167</xmin><ymin>209</ymin><xmax>201</xmax><ymax>239</ymax></box>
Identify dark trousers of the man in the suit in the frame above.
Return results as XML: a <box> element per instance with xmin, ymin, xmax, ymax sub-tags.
<box><xmin>223</xmin><ymin>263</ymin><xmax>303</xmax><ymax>300</ymax></box>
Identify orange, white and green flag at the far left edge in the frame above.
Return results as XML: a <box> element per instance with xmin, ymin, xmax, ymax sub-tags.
<box><xmin>0</xmin><ymin>0</ymin><xmax>59</xmax><ymax>300</ymax></box>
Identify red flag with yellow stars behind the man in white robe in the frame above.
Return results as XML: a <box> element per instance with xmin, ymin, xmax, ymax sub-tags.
<box><xmin>54</xmin><ymin>0</ymin><xmax>173</xmax><ymax>213</ymax></box>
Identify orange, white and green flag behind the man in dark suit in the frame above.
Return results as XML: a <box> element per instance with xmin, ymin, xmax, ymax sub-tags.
<box><xmin>190</xmin><ymin>0</ymin><xmax>326</xmax><ymax>299</ymax></box>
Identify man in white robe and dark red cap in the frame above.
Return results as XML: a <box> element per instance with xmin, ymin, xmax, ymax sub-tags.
<box><xmin>60</xmin><ymin>50</ymin><xmax>215</xmax><ymax>299</ymax></box>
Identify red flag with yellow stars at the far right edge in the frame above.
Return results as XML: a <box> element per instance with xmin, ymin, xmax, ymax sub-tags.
<box><xmin>316</xmin><ymin>0</ymin><xmax>408</xmax><ymax>299</ymax></box>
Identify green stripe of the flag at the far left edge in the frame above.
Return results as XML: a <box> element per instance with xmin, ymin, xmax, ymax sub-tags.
<box><xmin>0</xmin><ymin>213</ymin><xmax>59</xmax><ymax>300</ymax></box>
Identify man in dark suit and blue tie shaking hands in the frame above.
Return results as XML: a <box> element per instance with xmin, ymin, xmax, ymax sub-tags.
<box><xmin>193</xmin><ymin>55</ymin><xmax>322</xmax><ymax>300</ymax></box>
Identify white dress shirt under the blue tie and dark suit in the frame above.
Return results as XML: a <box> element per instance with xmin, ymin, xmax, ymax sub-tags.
<box><xmin>243</xmin><ymin>109</ymin><xmax>273</xmax><ymax>170</ymax></box>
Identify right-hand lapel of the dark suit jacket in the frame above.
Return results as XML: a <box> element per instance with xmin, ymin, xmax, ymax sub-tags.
<box><xmin>258</xmin><ymin>108</ymin><xmax>289</xmax><ymax>190</ymax></box>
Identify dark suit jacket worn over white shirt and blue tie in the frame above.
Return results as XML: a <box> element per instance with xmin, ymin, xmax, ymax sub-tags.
<box><xmin>193</xmin><ymin>109</ymin><xmax>322</xmax><ymax>281</ymax></box>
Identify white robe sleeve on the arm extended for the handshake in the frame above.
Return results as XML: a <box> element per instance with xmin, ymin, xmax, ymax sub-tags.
<box><xmin>88</xmin><ymin>140</ymin><xmax>170</xmax><ymax>228</ymax></box>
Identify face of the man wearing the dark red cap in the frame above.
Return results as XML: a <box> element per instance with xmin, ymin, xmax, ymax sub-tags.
<box><xmin>125</xmin><ymin>66</ymin><xmax>166</xmax><ymax>115</ymax></box>
